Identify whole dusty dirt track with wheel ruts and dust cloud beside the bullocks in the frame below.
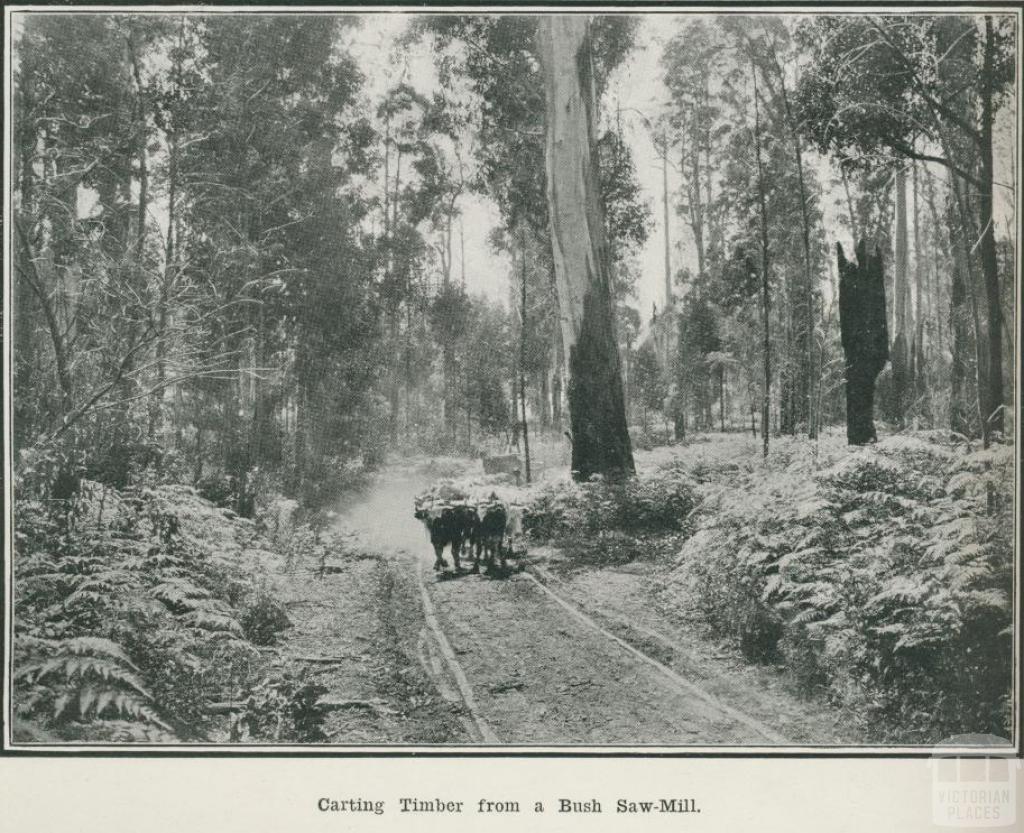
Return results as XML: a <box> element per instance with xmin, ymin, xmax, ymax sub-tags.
<box><xmin>278</xmin><ymin>461</ymin><xmax>846</xmax><ymax>747</ymax></box>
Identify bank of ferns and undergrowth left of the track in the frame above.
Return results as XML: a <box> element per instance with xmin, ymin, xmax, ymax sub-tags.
<box><xmin>13</xmin><ymin>455</ymin><xmax>339</xmax><ymax>743</ymax></box>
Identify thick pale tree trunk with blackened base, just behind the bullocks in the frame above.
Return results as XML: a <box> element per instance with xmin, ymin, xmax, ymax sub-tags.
<box><xmin>538</xmin><ymin>14</ymin><xmax>635</xmax><ymax>481</ymax></box>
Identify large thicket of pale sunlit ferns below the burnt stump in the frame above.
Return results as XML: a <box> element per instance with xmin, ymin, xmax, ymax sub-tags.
<box><xmin>667</xmin><ymin>434</ymin><xmax>1014</xmax><ymax>743</ymax></box>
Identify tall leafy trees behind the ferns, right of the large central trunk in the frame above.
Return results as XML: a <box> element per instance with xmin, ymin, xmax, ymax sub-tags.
<box><xmin>637</xmin><ymin>14</ymin><xmax>1016</xmax><ymax>450</ymax></box>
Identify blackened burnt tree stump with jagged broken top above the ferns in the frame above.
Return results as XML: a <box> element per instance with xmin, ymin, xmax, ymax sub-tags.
<box><xmin>836</xmin><ymin>240</ymin><xmax>889</xmax><ymax>446</ymax></box>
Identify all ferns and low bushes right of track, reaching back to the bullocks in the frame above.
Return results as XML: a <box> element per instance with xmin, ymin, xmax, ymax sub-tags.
<box><xmin>526</xmin><ymin>431</ymin><xmax>1014</xmax><ymax>743</ymax></box>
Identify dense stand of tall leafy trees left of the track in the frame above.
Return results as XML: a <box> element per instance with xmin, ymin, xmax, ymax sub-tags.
<box><xmin>14</xmin><ymin>15</ymin><xmax>528</xmax><ymax>506</ymax></box>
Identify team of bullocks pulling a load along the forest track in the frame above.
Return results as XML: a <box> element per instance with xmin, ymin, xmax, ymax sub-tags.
<box><xmin>413</xmin><ymin>484</ymin><xmax>522</xmax><ymax>573</ymax></box>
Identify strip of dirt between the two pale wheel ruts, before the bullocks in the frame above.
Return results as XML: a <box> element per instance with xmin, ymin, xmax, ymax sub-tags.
<box><xmin>423</xmin><ymin>574</ymin><xmax>782</xmax><ymax>746</ymax></box>
